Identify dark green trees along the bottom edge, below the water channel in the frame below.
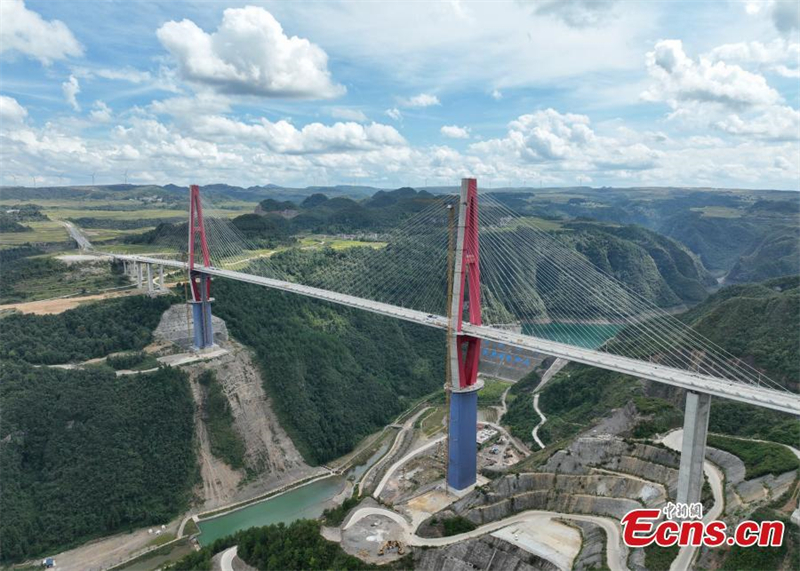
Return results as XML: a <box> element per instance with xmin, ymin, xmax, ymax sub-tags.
<box><xmin>169</xmin><ymin>519</ymin><xmax>376</xmax><ymax>571</ymax></box>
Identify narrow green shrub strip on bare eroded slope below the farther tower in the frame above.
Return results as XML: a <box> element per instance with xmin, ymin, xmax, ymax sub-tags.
<box><xmin>197</xmin><ymin>370</ymin><xmax>245</xmax><ymax>469</ymax></box>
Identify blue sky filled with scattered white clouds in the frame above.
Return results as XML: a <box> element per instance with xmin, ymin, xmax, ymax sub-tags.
<box><xmin>0</xmin><ymin>0</ymin><xmax>800</xmax><ymax>189</ymax></box>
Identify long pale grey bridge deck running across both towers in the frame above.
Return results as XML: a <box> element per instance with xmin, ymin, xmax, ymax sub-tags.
<box><xmin>105</xmin><ymin>254</ymin><xmax>800</xmax><ymax>416</ymax></box>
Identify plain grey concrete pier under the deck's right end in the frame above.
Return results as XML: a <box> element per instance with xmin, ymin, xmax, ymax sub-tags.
<box><xmin>677</xmin><ymin>391</ymin><xmax>711</xmax><ymax>504</ymax></box>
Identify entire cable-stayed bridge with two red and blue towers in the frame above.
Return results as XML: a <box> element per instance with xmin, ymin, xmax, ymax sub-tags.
<box><xmin>90</xmin><ymin>179</ymin><xmax>800</xmax><ymax>502</ymax></box>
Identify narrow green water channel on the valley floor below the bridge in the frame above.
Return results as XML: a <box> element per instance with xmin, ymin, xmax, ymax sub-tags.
<box><xmin>197</xmin><ymin>441</ymin><xmax>391</xmax><ymax>545</ymax></box>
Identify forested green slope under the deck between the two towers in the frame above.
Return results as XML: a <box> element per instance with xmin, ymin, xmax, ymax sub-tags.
<box><xmin>214</xmin><ymin>280</ymin><xmax>444</xmax><ymax>462</ymax></box>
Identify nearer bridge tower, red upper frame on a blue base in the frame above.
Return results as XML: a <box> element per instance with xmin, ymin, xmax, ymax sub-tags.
<box><xmin>447</xmin><ymin>178</ymin><xmax>481</xmax><ymax>491</ymax></box>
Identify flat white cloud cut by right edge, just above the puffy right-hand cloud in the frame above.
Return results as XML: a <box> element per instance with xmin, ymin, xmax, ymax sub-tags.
<box><xmin>706</xmin><ymin>39</ymin><xmax>800</xmax><ymax>78</ymax></box>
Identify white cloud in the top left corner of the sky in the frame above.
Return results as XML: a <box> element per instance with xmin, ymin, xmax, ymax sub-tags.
<box><xmin>0</xmin><ymin>0</ymin><xmax>83</xmax><ymax>65</ymax></box>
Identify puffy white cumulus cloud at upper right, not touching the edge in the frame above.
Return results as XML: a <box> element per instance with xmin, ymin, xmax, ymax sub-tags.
<box><xmin>642</xmin><ymin>40</ymin><xmax>781</xmax><ymax>109</ymax></box>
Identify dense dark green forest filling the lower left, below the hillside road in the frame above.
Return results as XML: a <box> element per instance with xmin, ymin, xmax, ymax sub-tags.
<box><xmin>0</xmin><ymin>361</ymin><xmax>197</xmax><ymax>562</ymax></box>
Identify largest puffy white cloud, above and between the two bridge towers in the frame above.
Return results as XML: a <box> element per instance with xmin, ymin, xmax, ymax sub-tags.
<box><xmin>157</xmin><ymin>6</ymin><xmax>346</xmax><ymax>99</ymax></box>
